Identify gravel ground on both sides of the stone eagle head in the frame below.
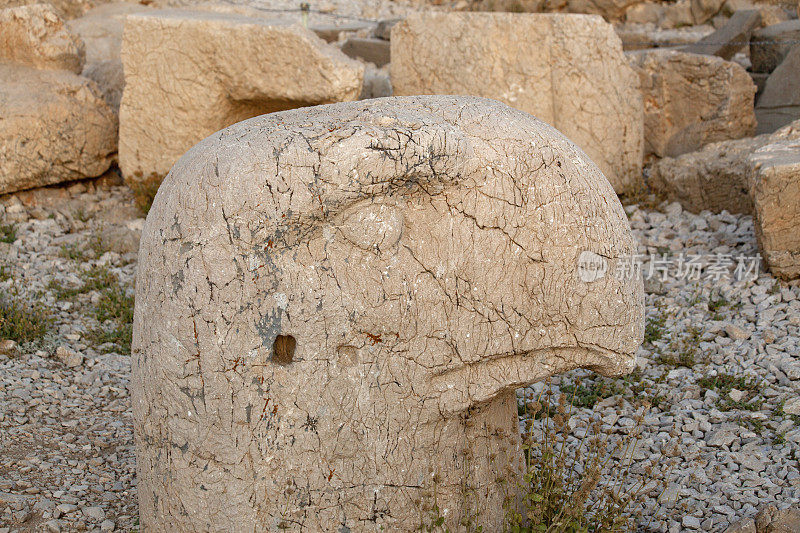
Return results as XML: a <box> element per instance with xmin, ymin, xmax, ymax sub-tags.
<box><xmin>0</xmin><ymin>175</ymin><xmax>800</xmax><ymax>532</ymax></box>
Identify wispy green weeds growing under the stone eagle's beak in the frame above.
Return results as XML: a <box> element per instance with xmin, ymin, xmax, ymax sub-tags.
<box><xmin>506</xmin><ymin>387</ymin><xmax>667</xmax><ymax>533</ymax></box>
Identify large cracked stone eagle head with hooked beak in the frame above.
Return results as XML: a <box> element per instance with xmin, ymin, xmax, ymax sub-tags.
<box><xmin>131</xmin><ymin>96</ymin><xmax>644</xmax><ymax>531</ymax></box>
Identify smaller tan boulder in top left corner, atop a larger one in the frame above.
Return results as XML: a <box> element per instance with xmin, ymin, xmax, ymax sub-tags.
<box><xmin>0</xmin><ymin>4</ymin><xmax>84</xmax><ymax>74</ymax></box>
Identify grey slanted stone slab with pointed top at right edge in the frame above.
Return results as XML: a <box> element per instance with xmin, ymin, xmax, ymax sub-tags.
<box><xmin>756</xmin><ymin>45</ymin><xmax>800</xmax><ymax>133</ymax></box>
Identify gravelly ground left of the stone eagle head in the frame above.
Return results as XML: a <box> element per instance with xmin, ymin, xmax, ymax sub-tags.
<box><xmin>0</xmin><ymin>177</ymin><xmax>138</xmax><ymax>532</ymax></box>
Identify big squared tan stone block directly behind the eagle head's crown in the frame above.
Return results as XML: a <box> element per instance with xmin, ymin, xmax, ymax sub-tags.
<box><xmin>391</xmin><ymin>13</ymin><xmax>644</xmax><ymax>194</ymax></box>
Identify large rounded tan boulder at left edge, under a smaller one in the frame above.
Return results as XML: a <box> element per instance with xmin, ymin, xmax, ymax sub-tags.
<box><xmin>0</xmin><ymin>64</ymin><xmax>117</xmax><ymax>194</ymax></box>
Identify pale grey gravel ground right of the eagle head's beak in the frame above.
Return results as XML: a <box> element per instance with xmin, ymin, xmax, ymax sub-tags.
<box><xmin>530</xmin><ymin>197</ymin><xmax>800</xmax><ymax>532</ymax></box>
